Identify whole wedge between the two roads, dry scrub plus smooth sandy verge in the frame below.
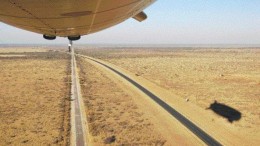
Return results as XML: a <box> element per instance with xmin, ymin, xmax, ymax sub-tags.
<box><xmin>77</xmin><ymin>59</ymin><xmax>202</xmax><ymax>145</ymax></box>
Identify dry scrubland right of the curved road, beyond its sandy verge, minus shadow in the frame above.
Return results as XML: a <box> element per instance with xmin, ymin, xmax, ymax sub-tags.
<box><xmin>77</xmin><ymin>48</ymin><xmax>260</xmax><ymax>139</ymax></box>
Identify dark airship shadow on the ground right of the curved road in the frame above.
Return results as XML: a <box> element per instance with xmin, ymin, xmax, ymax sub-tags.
<box><xmin>207</xmin><ymin>101</ymin><xmax>242</xmax><ymax>123</ymax></box>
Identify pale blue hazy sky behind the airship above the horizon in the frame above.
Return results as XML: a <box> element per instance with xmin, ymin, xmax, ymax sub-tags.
<box><xmin>0</xmin><ymin>0</ymin><xmax>260</xmax><ymax>44</ymax></box>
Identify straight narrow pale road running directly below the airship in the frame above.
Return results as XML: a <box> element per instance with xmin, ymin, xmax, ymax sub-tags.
<box><xmin>71</xmin><ymin>48</ymin><xmax>87</xmax><ymax>146</ymax></box>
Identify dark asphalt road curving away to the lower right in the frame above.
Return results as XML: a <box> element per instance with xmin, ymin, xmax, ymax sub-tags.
<box><xmin>80</xmin><ymin>55</ymin><xmax>222</xmax><ymax>146</ymax></box>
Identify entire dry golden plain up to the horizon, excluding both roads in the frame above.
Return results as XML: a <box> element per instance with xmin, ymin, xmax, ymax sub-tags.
<box><xmin>0</xmin><ymin>46</ymin><xmax>260</xmax><ymax>146</ymax></box>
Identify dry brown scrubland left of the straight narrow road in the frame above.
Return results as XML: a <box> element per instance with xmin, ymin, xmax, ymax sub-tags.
<box><xmin>0</xmin><ymin>48</ymin><xmax>70</xmax><ymax>146</ymax></box>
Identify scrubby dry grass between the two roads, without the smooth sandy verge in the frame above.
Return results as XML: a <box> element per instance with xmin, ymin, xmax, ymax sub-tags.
<box><xmin>78</xmin><ymin>59</ymin><xmax>165</xmax><ymax>145</ymax></box>
